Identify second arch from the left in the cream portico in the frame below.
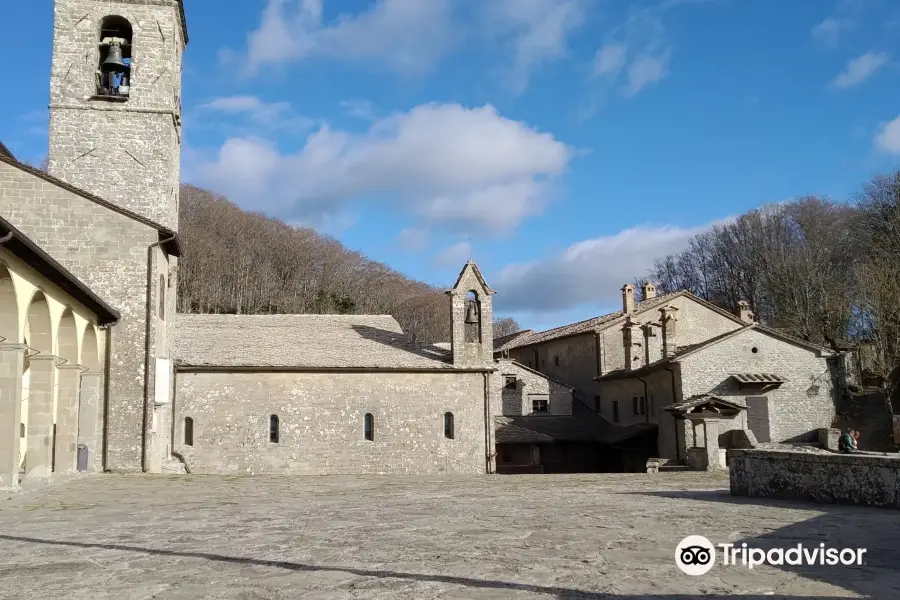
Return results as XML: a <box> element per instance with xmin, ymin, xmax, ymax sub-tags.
<box><xmin>25</xmin><ymin>290</ymin><xmax>57</xmax><ymax>478</ymax></box>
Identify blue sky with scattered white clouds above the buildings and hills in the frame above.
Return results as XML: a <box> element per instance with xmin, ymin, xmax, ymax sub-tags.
<box><xmin>0</xmin><ymin>0</ymin><xmax>900</xmax><ymax>328</ymax></box>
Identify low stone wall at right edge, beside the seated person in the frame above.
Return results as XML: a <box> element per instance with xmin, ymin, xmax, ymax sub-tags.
<box><xmin>728</xmin><ymin>449</ymin><xmax>900</xmax><ymax>509</ymax></box>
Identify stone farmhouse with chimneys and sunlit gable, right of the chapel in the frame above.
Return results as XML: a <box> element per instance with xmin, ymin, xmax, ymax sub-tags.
<box><xmin>495</xmin><ymin>283</ymin><xmax>842</xmax><ymax>470</ymax></box>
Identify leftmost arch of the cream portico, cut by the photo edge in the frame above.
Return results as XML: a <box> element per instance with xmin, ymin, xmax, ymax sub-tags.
<box><xmin>0</xmin><ymin>262</ymin><xmax>25</xmax><ymax>487</ymax></box>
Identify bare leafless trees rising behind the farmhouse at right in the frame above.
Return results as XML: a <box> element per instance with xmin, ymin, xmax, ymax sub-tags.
<box><xmin>638</xmin><ymin>171</ymin><xmax>900</xmax><ymax>398</ymax></box>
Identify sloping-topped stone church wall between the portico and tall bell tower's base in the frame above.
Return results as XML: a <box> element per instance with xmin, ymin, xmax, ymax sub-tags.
<box><xmin>0</xmin><ymin>162</ymin><xmax>159</xmax><ymax>471</ymax></box>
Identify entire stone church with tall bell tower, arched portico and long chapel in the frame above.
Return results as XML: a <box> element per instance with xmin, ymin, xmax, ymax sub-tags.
<box><xmin>0</xmin><ymin>0</ymin><xmax>520</xmax><ymax>486</ymax></box>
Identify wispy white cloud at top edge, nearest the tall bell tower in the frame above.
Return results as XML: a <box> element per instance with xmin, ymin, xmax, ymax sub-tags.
<box><xmin>237</xmin><ymin>0</ymin><xmax>455</xmax><ymax>73</ymax></box>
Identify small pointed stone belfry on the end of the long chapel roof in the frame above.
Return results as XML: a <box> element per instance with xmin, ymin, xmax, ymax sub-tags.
<box><xmin>447</xmin><ymin>260</ymin><xmax>496</xmax><ymax>367</ymax></box>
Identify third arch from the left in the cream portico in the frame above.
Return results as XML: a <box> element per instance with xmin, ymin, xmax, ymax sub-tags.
<box><xmin>53</xmin><ymin>307</ymin><xmax>81</xmax><ymax>473</ymax></box>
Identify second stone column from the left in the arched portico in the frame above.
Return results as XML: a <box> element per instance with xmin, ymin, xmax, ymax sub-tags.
<box><xmin>25</xmin><ymin>354</ymin><xmax>58</xmax><ymax>479</ymax></box>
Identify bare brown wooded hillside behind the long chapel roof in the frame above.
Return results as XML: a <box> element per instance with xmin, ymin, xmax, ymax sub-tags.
<box><xmin>178</xmin><ymin>185</ymin><xmax>518</xmax><ymax>342</ymax></box>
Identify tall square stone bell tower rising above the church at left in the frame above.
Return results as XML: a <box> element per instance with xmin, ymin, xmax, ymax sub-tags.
<box><xmin>48</xmin><ymin>0</ymin><xmax>188</xmax><ymax>231</ymax></box>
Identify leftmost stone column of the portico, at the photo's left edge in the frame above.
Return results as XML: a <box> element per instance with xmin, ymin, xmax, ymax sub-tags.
<box><xmin>0</xmin><ymin>344</ymin><xmax>26</xmax><ymax>488</ymax></box>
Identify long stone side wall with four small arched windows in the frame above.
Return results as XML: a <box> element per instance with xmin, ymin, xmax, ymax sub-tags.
<box><xmin>174</xmin><ymin>372</ymin><xmax>488</xmax><ymax>475</ymax></box>
